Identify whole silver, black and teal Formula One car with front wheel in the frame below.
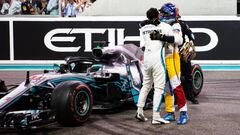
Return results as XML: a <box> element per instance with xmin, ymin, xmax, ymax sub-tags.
<box><xmin>0</xmin><ymin>44</ymin><xmax>203</xmax><ymax>128</ymax></box>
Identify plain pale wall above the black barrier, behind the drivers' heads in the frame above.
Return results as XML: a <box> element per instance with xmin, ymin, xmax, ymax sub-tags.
<box><xmin>82</xmin><ymin>0</ymin><xmax>237</xmax><ymax>16</ymax></box>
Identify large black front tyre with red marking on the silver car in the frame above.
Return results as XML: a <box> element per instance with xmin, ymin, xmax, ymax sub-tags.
<box><xmin>51</xmin><ymin>81</ymin><xmax>93</xmax><ymax>126</ymax></box>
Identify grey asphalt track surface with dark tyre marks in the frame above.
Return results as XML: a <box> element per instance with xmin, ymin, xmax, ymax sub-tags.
<box><xmin>0</xmin><ymin>71</ymin><xmax>240</xmax><ymax>135</ymax></box>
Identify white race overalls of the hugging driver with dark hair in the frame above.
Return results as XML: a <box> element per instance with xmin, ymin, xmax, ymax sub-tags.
<box><xmin>137</xmin><ymin>23</ymin><xmax>173</xmax><ymax>117</ymax></box>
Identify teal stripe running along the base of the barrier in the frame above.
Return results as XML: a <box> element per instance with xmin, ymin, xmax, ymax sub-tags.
<box><xmin>0</xmin><ymin>65</ymin><xmax>240</xmax><ymax>71</ymax></box>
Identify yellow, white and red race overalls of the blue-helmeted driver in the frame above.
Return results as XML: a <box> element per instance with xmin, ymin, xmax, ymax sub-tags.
<box><xmin>165</xmin><ymin>23</ymin><xmax>187</xmax><ymax>112</ymax></box>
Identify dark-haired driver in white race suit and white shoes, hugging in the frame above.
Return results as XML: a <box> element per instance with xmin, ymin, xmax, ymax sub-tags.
<box><xmin>135</xmin><ymin>8</ymin><xmax>178</xmax><ymax>124</ymax></box>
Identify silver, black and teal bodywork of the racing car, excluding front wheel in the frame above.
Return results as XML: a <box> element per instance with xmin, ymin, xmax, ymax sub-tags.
<box><xmin>0</xmin><ymin>44</ymin><xmax>143</xmax><ymax>128</ymax></box>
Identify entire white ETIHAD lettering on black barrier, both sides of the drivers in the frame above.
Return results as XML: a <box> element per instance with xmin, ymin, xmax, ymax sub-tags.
<box><xmin>44</xmin><ymin>28</ymin><xmax>218</xmax><ymax>52</ymax></box>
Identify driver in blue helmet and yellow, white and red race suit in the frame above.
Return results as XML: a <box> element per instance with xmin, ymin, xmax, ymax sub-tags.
<box><xmin>151</xmin><ymin>3</ymin><xmax>189</xmax><ymax>125</ymax></box>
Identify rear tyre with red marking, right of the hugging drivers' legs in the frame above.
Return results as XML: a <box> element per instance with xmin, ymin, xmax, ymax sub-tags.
<box><xmin>192</xmin><ymin>64</ymin><xmax>204</xmax><ymax>97</ymax></box>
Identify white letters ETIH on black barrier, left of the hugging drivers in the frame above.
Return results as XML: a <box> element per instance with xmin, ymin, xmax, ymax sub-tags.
<box><xmin>44</xmin><ymin>28</ymin><xmax>140</xmax><ymax>52</ymax></box>
